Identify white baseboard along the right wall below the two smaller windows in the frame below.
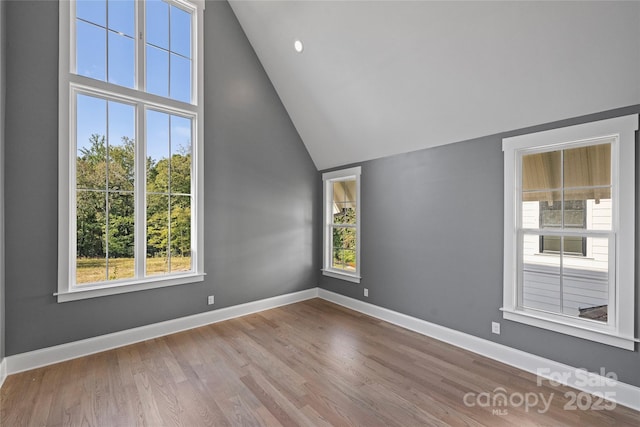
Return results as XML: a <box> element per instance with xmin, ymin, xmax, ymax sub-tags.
<box><xmin>318</xmin><ymin>289</ymin><xmax>640</xmax><ymax>411</ymax></box>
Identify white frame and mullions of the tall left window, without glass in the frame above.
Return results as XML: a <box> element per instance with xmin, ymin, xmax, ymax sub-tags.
<box><xmin>54</xmin><ymin>0</ymin><xmax>205</xmax><ymax>303</ymax></box>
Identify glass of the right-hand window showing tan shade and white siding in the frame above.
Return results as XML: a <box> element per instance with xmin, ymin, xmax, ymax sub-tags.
<box><xmin>520</xmin><ymin>142</ymin><xmax>613</xmax><ymax>323</ymax></box>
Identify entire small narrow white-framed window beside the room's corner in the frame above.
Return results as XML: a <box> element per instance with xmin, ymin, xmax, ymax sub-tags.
<box><xmin>322</xmin><ymin>167</ymin><xmax>360</xmax><ymax>283</ymax></box>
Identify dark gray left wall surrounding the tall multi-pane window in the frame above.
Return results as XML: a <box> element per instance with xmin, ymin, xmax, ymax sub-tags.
<box><xmin>5</xmin><ymin>1</ymin><xmax>320</xmax><ymax>355</ymax></box>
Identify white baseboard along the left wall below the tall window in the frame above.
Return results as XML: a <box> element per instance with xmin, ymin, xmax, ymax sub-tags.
<box><xmin>0</xmin><ymin>288</ymin><xmax>318</xmax><ymax>378</ymax></box>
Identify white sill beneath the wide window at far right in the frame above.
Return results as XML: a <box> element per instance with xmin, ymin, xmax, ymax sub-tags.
<box><xmin>500</xmin><ymin>308</ymin><xmax>640</xmax><ymax>351</ymax></box>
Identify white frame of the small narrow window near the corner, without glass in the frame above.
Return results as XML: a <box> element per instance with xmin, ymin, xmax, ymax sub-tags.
<box><xmin>322</xmin><ymin>166</ymin><xmax>362</xmax><ymax>283</ymax></box>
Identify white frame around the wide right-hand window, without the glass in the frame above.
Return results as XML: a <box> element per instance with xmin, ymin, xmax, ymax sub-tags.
<box><xmin>501</xmin><ymin>114</ymin><xmax>638</xmax><ymax>351</ymax></box>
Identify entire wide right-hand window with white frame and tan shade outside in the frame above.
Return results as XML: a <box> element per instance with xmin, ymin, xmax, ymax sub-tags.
<box><xmin>502</xmin><ymin>115</ymin><xmax>638</xmax><ymax>350</ymax></box>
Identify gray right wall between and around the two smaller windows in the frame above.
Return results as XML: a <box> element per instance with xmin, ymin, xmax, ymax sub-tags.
<box><xmin>318</xmin><ymin>106</ymin><xmax>640</xmax><ymax>386</ymax></box>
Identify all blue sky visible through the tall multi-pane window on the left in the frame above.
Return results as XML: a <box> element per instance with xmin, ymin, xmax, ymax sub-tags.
<box><xmin>76</xmin><ymin>0</ymin><xmax>192</xmax><ymax>170</ymax></box>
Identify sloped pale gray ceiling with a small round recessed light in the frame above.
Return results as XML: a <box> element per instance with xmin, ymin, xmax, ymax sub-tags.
<box><xmin>230</xmin><ymin>0</ymin><xmax>640</xmax><ymax>170</ymax></box>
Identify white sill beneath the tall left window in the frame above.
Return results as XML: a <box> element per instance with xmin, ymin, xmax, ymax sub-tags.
<box><xmin>54</xmin><ymin>273</ymin><xmax>205</xmax><ymax>303</ymax></box>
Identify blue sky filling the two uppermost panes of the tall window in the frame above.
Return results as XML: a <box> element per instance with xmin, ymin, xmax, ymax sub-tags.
<box><xmin>76</xmin><ymin>0</ymin><xmax>192</xmax><ymax>98</ymax></box>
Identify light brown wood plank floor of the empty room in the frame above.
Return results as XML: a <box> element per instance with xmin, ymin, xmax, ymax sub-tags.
<box><xmin>0</xmin><ymin>299</ymin><xmax>640</xmax><ymax>427</ymax></box>
